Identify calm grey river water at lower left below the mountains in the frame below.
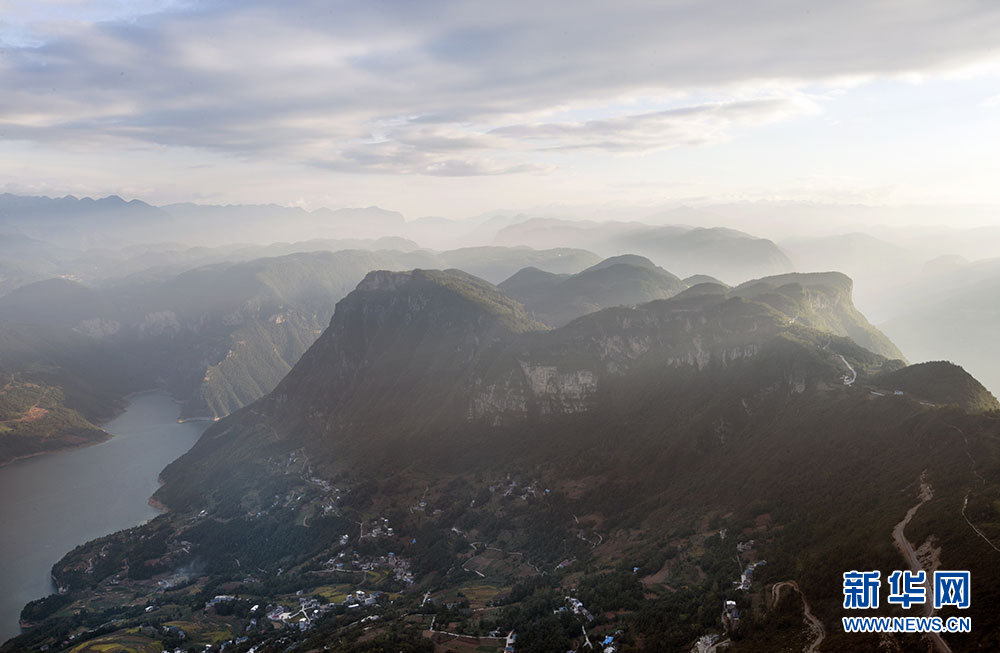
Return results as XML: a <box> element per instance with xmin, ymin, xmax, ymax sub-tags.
<box><xmin>0</xmin><ymin>393</ymin><xmax>209</xmax><ymax>642</ymax></box>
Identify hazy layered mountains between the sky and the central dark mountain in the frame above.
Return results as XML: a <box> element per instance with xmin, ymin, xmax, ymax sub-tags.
<box><xmin>0</xmin><ymin>194</ymin><xmax>1000</xmax><ymax>448</ymax></box>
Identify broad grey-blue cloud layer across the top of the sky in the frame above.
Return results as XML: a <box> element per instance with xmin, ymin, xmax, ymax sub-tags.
<box><xmin>0</xmin><ymin>0</ymin><xmax>1000</xmax><ymax>176</ymax></box>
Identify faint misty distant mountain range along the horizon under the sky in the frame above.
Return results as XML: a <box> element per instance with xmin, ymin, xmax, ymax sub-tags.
<box><xmin>0</xmin><ymin>194</ymin><xmax>792</xmax><ymax>295</ymax></box>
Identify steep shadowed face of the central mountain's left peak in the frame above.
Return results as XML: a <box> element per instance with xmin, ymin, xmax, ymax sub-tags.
<box><xmin>265</xmin><ymin>270</ymin><xmax>545</xmax><ymax>432</ymax></box>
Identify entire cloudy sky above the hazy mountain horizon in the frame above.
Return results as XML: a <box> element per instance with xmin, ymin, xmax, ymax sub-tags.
<box><xmin>0</xmin><ymin>0</ymin><xmax>1000</xmax><ymax>217</ymax></box>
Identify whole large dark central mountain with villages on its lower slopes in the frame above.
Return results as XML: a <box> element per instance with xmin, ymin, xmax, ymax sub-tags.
<box><xmin>9</xmin><ymin>264</ymin><xmax>1000</xmax><ymax>653</ymax></box>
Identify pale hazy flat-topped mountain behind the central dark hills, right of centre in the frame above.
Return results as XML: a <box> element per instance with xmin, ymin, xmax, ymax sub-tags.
<box><xmin>495</xmin><ymin>218</ymin><xmax>793</xmax><ymax>283</ymax></box>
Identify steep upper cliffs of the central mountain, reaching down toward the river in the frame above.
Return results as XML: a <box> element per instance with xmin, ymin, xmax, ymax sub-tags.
<box><xmin>157</xmin><ymin>270</ymin><xmax>924</xmax><ymax>506</ymax></box>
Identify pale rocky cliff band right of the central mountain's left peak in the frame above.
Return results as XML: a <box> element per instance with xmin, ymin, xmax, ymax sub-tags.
<box><xmin>467</xmin><ymin>295</ymin><xmax>824</xmax><ymax>424</ymax></box>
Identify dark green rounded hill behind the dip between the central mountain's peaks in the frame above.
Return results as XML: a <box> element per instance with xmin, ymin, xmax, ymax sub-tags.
<box><xmin>499</xmin><ymin>255</ymin><xmax>685</xmax><ymax>326</ymax></box>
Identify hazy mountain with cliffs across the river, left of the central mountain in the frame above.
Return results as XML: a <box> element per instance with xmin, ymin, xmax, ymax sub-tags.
<box><xmin>0</xmin><ymin>247</ymin><xmax>597</xmax><ymax>417</ymax></box>
